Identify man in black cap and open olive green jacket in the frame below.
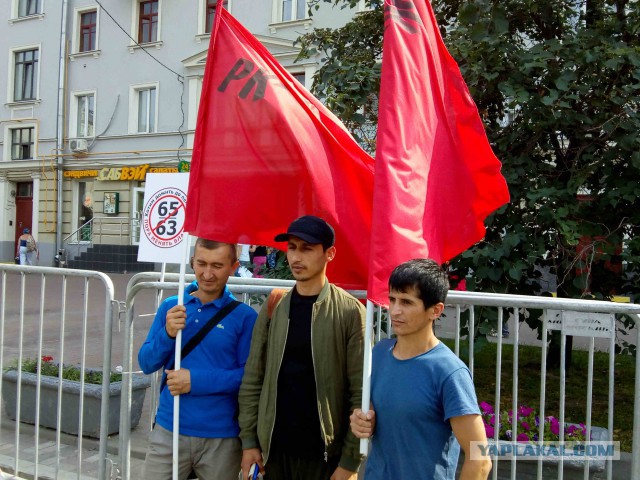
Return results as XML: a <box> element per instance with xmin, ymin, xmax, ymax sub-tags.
<box><xmin>239</xmin><ymin>215</ymin><xmax>365</xmax><ymax>480</ymax></box>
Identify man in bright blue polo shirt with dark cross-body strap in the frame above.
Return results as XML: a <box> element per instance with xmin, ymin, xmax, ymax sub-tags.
<box><xmin>138</xmin><ymin>238</ymin><xmax>257</xmax><ymax>480</ymax></box>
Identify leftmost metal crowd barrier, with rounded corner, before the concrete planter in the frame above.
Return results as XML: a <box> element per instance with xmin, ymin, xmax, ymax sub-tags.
<box><xmin>0</xmin><ymin>265</ymin><xmax>114</xmax><ymax>480</ymax></box>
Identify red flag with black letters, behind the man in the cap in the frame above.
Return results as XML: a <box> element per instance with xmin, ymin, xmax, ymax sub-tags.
<box><xmin>185</xmin><ymin>5</ymin><xmax>373</xmax><ymax>289</ymax></box>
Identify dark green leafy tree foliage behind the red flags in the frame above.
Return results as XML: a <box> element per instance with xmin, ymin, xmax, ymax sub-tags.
<box><xmin>300</xmin><ymin>0</ymin><xmax>640</xmax><ymax>352</ymax></box>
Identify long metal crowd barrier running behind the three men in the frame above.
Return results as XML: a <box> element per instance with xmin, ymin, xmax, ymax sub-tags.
<box><xmin>119</xmin><ymin>273</ymin><xmax>640</xmax><ymax>480</ymax></box>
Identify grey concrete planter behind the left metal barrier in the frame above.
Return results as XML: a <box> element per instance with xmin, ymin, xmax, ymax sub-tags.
<box><xmin>2</xmin><ymin>370</ymin><xmax>151</xmax><ymax>438</ymax></box>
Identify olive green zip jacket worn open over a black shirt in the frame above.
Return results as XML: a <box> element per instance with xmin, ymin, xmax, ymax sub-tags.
<box><xmin>238</xmin><ymin>281</ymin><xmax>365</xmax><ymax>472</ymax></box>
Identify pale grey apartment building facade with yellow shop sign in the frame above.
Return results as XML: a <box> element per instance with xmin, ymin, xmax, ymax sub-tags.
<box><xmin>0</xmin><ymin>0</ymin><xmax>365</xmax><ymax>265</ymax></box>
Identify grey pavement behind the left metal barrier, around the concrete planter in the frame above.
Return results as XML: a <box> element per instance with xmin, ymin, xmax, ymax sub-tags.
<box><xmin>0</xmin><ymin>274</ymin><xmax>159</xmax><ymax>479</ymax></box>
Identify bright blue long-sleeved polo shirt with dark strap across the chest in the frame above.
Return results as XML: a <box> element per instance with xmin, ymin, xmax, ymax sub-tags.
<box><xmin>138</xmin><ymin>282</ymin><xmax>257</xmax><ymax>438</ymax></box>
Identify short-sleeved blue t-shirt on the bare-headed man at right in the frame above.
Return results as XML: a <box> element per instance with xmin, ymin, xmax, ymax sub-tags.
<box><xmin>365</xmin><ymin>339</ymin><xmax>480</xmax><ymax>480</ymax></box>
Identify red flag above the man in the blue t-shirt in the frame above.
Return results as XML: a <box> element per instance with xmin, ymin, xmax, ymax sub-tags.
<box><xmin>368</xmin><ymin>0</ymin><xmax>509</xmax><ymax>305</ymax></box>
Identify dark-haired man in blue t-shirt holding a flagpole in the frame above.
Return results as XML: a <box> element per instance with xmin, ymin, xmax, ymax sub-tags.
<box><xmin>351</xmin><ymin>259</ymin><xmax>491</xmax><ymax>480</ymax></box>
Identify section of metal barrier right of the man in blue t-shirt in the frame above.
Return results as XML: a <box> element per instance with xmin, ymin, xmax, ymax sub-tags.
<box><xmin>438</xmin><ymin>291</ymin><xmax>640</xmax><ymax>480</ymax></box>
